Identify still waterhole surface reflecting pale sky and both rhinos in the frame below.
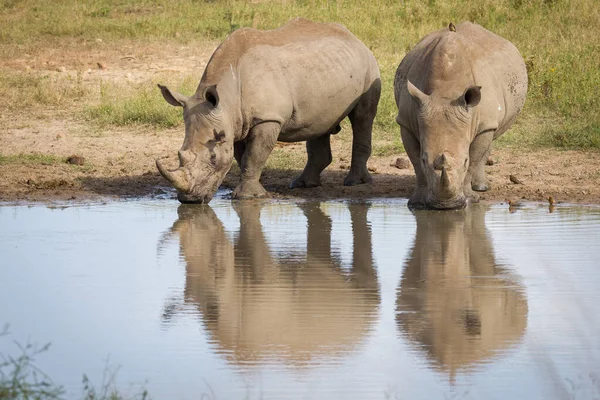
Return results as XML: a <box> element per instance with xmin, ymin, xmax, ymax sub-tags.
<box><xmin>0</xmin><ymin>200</ymin><xmax>600</xmax><ymax>399</ymax></box>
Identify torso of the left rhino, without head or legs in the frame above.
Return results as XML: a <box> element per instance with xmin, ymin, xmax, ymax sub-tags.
<box><xmin>199</xmin><ymin>18</ymin><xmax>379</xmax><ymax>141</ymax></box>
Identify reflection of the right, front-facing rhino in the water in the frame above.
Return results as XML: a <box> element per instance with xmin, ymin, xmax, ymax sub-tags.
<box><xmin>396</xmin><ymin>207</ymin><xmax>527</xmax><ymax>379</ymax></box>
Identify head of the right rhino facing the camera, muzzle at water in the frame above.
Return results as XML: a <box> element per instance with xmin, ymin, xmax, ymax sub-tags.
<box><xmin>407</xmin><ymin>81</ymin><xmax>481</xmax><ymax>209</ymax></box>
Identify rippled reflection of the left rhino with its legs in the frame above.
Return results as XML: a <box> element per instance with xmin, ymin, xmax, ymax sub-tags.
<box><xmin>166</xmin><ymin>202</ymin><xmax>379</xmax><ymax>365</ymax></box>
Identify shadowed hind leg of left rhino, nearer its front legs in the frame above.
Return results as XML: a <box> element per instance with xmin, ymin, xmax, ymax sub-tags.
<box><xmin>290</xmin><ymin>133</ymin><xmax>332</xmax><ymax>189</ymax></box>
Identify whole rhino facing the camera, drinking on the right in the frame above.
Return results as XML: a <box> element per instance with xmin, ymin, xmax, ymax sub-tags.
<box><xmin>394</xmin><ymin>22</ymin><xmax>527</xmax><ymax>209</ymax></box>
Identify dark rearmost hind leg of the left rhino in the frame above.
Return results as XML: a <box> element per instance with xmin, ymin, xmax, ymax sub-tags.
<box><xmin>344</xmin><ymin>80</ymin><xmax>381</xmax><ymax>186</ymax></box>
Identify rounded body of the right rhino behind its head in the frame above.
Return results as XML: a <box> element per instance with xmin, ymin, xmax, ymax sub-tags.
<box><xmin>394</xmin><ymin>22</ymin><xmax>527</xmax><ymax>137</ymax></box>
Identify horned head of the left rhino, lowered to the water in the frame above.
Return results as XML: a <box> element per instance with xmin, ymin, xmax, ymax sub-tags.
<box><xmin>156</xmin><ymin>85</ymin><xmax>233</xmax><ymax>203</ymax></box>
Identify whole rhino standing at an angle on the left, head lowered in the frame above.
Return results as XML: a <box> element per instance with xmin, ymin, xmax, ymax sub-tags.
<box><xmin>156</xmin><ymin>18</ymin><xmax>381</xmax><ymax>203</ymax></box>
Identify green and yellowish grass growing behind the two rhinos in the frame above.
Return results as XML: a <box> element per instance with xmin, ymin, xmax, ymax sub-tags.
<box><xmin>0</xmin><ymin>0</ymin><xmax>600</xmax><ymax>149</ymax></box>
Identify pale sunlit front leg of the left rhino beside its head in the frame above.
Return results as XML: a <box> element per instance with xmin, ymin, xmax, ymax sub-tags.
<box><xmin>233</xmin><ymin>122</ymin><xmax>280</xmax><ymax>199</ymax></box>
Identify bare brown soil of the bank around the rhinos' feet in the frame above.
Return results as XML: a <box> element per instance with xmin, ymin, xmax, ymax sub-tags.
<box><xmin>0</xmin><ymin>43</ymin><xmax>600</xmax><ymax>204</ymax></box>
